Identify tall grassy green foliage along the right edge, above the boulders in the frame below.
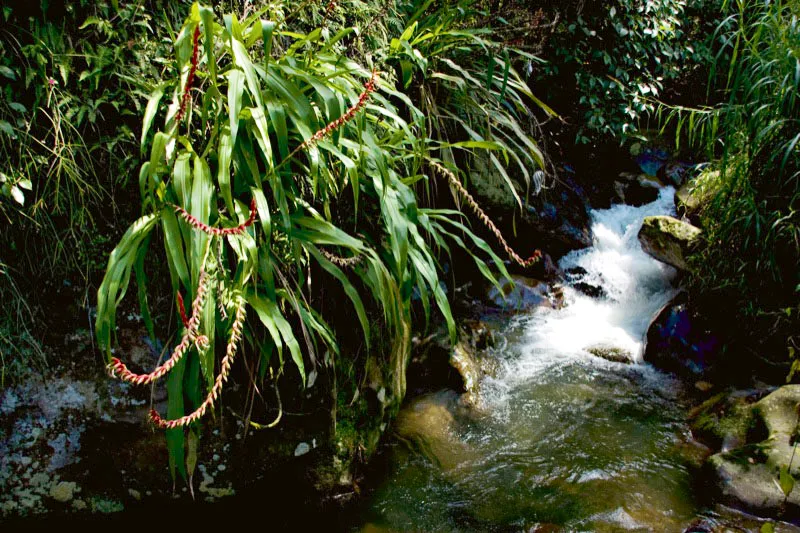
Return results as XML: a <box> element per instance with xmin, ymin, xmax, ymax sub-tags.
<box><xmin>663</xmin><ymin>0</ymin><xmax>800</xmax><ymax>364</ymax></box>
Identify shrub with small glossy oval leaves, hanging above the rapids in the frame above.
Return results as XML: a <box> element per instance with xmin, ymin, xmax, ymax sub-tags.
<box><xmin>533</xmin><ymin>0</ymin><xmax>713</xmax><ymax>143</ymax></box>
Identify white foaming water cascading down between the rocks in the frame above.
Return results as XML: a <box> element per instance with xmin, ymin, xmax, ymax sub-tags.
<box><xmin>487</xmin><ymin>187</ymin><xmax>675</xmax><ymax>394</ymax></box>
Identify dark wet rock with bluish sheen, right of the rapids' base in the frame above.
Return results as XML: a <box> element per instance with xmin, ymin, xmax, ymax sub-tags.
<box><xmin>644</xmin><ymin>293</ymin><xmax>722</xmax><ymax>380</ymax></box>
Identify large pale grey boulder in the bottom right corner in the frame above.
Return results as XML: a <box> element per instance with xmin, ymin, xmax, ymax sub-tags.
<box><xmin>708</xmin><ymin>385</ymin><xmax>800</xmax><ymax>518</ymax></box>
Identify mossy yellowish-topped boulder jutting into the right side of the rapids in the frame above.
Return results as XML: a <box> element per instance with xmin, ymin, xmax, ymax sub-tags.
<box><xmin>639</xmin><ymin>216</ymin><xmax>701</xmax><ymax>270</ymax></box>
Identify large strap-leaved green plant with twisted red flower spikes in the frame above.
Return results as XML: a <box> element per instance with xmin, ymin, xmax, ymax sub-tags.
<box><xmin>92</xmin><ymin>0</ymin><xmax>538</xmax><ymax>480</ymax></box>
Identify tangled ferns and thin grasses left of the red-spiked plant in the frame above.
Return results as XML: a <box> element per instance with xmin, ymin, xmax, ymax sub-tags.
<box><xmin>0</xmin><ymin>0</ymin><xmax>192</xmax><ymax>383</ymax></box>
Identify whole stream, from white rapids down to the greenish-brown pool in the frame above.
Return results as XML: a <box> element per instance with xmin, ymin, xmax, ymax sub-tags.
<box><xmin>356</xmin><ymin>188</ymin><xmax>708</xmax><ymax>531</ymax></box>
